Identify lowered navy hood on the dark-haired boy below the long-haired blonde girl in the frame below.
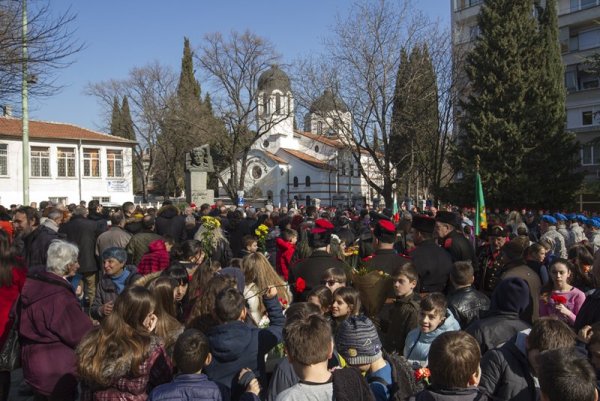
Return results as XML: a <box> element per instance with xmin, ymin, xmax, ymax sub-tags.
<box><xmin>207</xmin><ymin>320</ymin><xmax>253</xmax><ymax>362</ymax></box>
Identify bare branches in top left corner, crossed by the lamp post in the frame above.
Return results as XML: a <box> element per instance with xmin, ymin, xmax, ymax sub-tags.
<box><xmin>0</xmin><ymin>1</ymin><xmax>83</xmax><ymax>106</ymax></box>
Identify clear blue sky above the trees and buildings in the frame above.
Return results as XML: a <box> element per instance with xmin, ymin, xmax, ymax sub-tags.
<box><xmin>25</xmin><ymin>0</ymin><xmax>450</xmax><ymax>130</ymax></box>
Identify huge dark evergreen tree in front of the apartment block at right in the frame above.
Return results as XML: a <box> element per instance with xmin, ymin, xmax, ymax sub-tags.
<box><xmin>451</xmin><ymin>0</ymin><xmax>580</xmax><ymax>207</ymax></box>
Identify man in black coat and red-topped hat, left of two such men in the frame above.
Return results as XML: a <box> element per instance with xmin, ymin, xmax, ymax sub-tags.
<box><xmin>288</xmin><ymin>219</ymin><xmax>348</xmax><ymax>302</ymax></box>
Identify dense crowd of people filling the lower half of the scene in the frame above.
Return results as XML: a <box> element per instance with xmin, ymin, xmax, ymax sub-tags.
<box><xmin>0</xmin><ymin>201</ymin><xmax>600</xmax><ymax>401</ymax></box>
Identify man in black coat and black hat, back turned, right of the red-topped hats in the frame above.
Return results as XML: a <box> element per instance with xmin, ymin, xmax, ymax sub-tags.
<box><xmin>409</xmin><ymin>215</ymin><xmax>452</xmax><ymax>293</ymax></box>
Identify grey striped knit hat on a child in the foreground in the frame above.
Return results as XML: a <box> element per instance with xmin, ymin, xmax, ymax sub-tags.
<box><xmin>335</xmin><ymin>315</ymin><xmax>382</xmax><ymax>365</ymax></box>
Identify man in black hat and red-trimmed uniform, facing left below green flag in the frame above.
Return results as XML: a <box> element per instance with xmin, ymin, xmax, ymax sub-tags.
<box><xmin>433</xmin><ymin>211</ymin><xmax>478</xmax><ymax>273</ymax></box>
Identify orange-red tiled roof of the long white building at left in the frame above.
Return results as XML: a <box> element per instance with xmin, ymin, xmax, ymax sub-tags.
<box><xmin>0</xmin><ymin>117</ymin><xmax>135</xmax><ymax>144</ymax></box>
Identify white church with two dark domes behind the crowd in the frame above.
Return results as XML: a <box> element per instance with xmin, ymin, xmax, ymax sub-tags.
<box><xmin>219</xmin><ymin>66</ymin><xmax>380</xmax><ymax>207</ymax></box>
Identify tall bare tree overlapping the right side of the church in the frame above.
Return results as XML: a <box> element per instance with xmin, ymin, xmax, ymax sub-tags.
<box><xmin>295</xmin><ymin>0</ymin><xmax>448</xmax><ymax>205</ymax></box>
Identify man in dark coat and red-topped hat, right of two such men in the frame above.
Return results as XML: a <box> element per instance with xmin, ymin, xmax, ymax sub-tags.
<box><xmin>363</xmin><ymin>218</ymin><xmax>410</xmax><ymax>274</ymax></box>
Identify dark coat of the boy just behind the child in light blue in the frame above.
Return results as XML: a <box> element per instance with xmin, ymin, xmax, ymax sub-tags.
<box><xmin>379</xmin><ymin>292</ymin><xmax>421</xmax><ymax>354</ymax></box>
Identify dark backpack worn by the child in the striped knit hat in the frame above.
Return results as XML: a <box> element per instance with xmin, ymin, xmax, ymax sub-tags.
<box><xmin>368</xmin><ymin>350</ymin><xmax>424</xmax><ymax>401</ymax></box>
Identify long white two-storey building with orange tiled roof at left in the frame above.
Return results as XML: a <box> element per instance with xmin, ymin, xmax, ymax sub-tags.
<box><xmin>0</xmin><ymin>117</ymin><xmax>135</xmax><ymax>206</ymax></box>
